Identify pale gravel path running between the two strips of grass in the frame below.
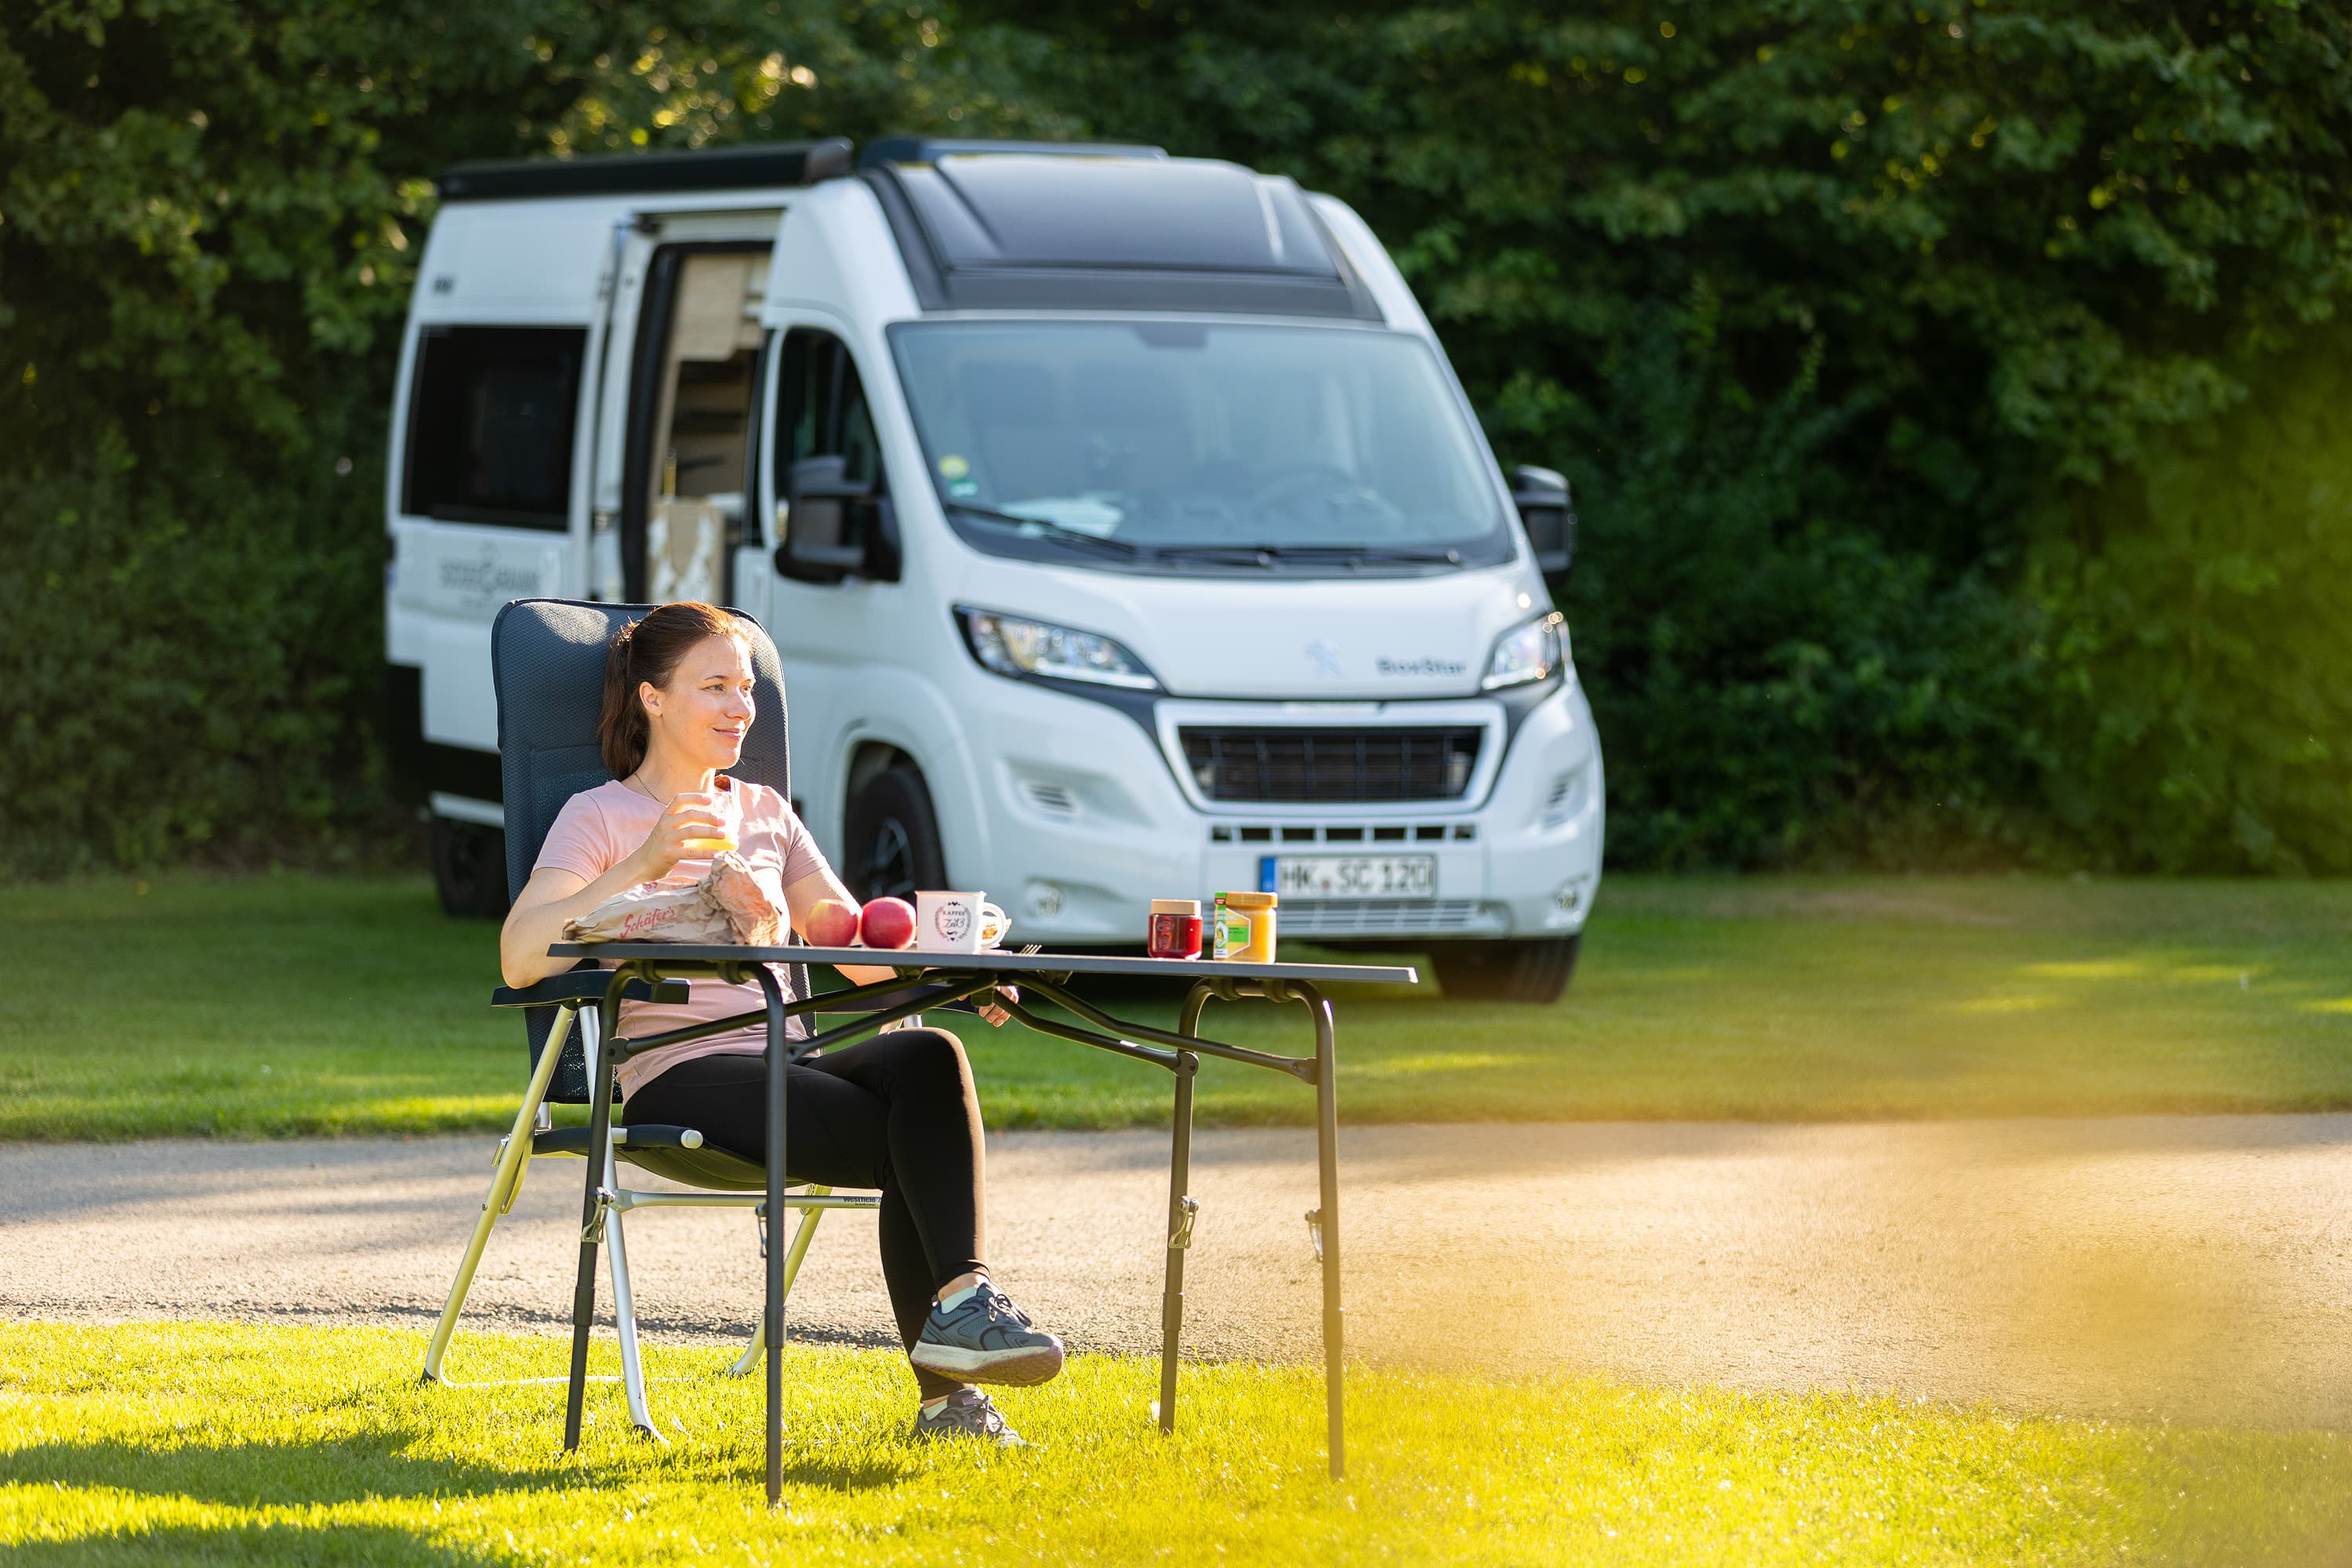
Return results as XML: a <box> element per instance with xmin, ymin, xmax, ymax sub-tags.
<box><xmin>0</xmin><ymin>1116</ymin><xmax>2352</xmax><ymax>1427</ymax></box>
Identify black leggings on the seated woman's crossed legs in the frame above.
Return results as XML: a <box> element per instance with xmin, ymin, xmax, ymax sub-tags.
<box><xmin>626</xmin><ymin>1029</ymin><xmax>988</xmax><ymax>1399</ymax></box>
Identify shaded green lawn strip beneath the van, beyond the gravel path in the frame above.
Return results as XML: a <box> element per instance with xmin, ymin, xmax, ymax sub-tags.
<box><xmin>0</xmin><ymin>874</ymin><xmax>2352</xmax><ymax>1138</ymax></box>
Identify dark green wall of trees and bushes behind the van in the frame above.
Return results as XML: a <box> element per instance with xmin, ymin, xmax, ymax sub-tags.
<box><xmin>0</xmin><ymin>0</ymin><xmax>2352</xmax><ymax>874</ymax></box>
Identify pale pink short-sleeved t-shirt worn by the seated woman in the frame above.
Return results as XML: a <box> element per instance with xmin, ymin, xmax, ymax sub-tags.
<box><xmin>534</xmin><ymin>774</ymin><xmax>826</xmax><ymax>1098</ymax></box>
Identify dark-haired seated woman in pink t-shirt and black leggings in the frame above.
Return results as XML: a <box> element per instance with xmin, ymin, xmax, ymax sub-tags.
<box><xmin>499</xmin><ymin>604</ymin><xmax>1061</xmax><ymax>1446</ymax></box>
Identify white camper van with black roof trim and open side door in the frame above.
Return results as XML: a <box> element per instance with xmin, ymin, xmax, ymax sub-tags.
<box><xmin>386</xmin><ymin>139</ymin><xmax>1602</xmax><ymax>1001</ymax></box>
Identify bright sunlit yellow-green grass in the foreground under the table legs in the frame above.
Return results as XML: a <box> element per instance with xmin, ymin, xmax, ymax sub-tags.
<box><xmin>0</xmin><ymin>1323</ymin><xmax>2352</xmax><ymax>1568</ymax></box>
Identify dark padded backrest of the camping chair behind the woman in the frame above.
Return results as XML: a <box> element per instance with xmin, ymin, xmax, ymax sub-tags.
<box><xmin>489</xmin><ymin>600</ymin><xmax>807</xmax><ymax>1105</ymax></box>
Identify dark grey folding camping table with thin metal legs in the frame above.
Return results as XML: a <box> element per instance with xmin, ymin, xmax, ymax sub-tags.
<box><xmin>548</xmin><ymin>942</ymin><xmax>1421</xmax><ymax>1504</ymax></box>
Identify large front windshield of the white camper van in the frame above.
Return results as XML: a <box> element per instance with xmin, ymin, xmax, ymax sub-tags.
<box><xmin>891</xmin><ymin>322</ymin><xmax>1512</xmax><ymax>572</ymax></box>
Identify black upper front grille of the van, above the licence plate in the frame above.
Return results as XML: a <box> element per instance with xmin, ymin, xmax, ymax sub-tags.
<box><xmin>1176</xmin><ymin>724</ymin><xmax>1484</xmax><ymax>801</ymax></box>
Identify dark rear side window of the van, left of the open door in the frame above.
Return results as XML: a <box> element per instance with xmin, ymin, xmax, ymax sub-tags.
<box><xmin>400</xmin><ymin>327</ymin><xmax>588</xmax><ymax>529</ymax></box>
